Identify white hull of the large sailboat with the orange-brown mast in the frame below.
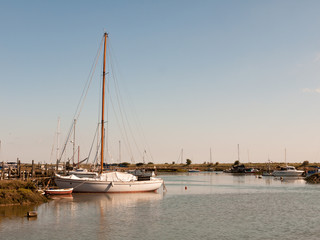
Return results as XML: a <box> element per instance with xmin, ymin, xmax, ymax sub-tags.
<box><xmin>55</xmin><ymin>175</ymin><xmax>163</xmax><ymax>193</ymax></box>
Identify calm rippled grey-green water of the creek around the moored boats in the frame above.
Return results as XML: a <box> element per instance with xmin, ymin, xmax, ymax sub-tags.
<box><xmin>0</xmin><ymin>173</ymin><xmax>320</xmax><ymax>240</ymax></box>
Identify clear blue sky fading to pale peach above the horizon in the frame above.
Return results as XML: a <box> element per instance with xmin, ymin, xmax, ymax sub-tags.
<box><xmin>0</xmin><ymin>0</ymin><xmax>320</xmax><ymax>163</ymax></box>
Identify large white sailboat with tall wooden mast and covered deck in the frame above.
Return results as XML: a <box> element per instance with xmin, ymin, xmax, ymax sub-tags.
<box><xmin>55</xmin><ymin>33</ymin><xmax>163</xmax><ymax>193</ymax></box>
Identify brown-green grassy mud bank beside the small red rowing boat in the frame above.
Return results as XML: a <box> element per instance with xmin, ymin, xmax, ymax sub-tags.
<box><xmin>0</xmin><ymin>180</ymin><xmax>48</xmax><ymax>205</ymax></box>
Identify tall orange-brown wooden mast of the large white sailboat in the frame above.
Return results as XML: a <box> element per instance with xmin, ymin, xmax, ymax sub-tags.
<box><xmin>100</xmin><ymin>33</ymin><xmax>108</xmax><ymax>173</ymax></box>
